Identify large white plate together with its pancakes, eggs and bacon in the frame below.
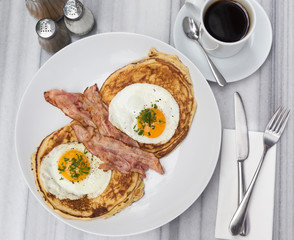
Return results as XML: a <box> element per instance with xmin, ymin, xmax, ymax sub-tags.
<box><xmin>15</xmin><ymin>33</ymin><xmax>221</xmax><ymax>236</ymax></box>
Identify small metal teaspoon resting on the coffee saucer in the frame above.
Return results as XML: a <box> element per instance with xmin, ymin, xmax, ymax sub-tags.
<box><xmin>183</xmin><ymin>17</ymin><xmax>227</xmax><ymax>87</ymax></box>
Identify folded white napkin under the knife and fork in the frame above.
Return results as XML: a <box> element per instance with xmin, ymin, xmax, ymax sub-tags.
<box><xmin>215</xmin><ymin>129</ymin><xmax>276</xmax><ymax>240</ymax></box>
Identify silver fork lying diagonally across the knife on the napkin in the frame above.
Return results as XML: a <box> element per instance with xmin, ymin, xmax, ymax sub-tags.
<box><xmin>229</xmin><ymin>107</ymin><xmax>290</xmax><ymax>235</ymax></box>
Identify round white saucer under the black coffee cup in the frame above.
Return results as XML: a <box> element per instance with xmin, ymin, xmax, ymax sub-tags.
<box><xmin>173</xmin><ymin>1</ymin><xmax>272</xmax><ymax>82</ymax></box>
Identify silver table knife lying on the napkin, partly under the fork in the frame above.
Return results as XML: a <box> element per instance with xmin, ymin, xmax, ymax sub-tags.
<box><xmin>234</xmin><ymin>92</ymin><xmax>249</xmax><ymax>236</ymax></box>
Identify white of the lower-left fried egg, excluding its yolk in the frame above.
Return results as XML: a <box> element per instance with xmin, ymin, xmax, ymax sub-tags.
<box><xmin>40</xmin><ymin>142</ymin><xmax>111</xmax><ymax>200</ymax></box>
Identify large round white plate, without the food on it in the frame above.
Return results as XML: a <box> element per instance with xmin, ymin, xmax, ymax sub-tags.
<box><xmin>15</xmin><ymin>33</ymin><xmax>221</xmax><ymax>236</ymax></box>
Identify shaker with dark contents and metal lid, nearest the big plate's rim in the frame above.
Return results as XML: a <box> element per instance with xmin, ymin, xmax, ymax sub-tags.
<box><xmin>36</xmin><ymin>18</ymin><xmax>70</xmax><ymax>52</ymax></box>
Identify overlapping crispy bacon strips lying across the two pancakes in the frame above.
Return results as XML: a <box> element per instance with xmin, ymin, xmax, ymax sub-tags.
<box><xmin>44</xmin><ymin>85</ymin><xmax>163</xmax><ymax>177</ymax></box>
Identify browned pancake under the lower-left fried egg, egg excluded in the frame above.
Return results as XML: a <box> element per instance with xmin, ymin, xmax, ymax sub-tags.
<box><xmin>31</xmin><ymin>122</ymin><xmax>144</xmax><ymax>220</ymax></box>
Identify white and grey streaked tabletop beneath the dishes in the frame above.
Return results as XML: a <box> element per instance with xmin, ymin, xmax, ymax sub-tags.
<box><xmin>0</xmin><ymin>0</ymin><xmax>294</xmax><ymax>240</ymax></box>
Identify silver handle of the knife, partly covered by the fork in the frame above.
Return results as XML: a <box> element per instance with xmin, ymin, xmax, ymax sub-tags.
<box><xmin>238</xmin><ymin>161</ymin><xmax>248</xmax><ymax>236</ymax></box>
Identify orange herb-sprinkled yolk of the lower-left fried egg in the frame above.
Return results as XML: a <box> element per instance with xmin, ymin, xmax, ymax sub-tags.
<box><xmin>58</xmin><ymin>149</ymin><xmax>90</xmax><ymax>183</ymax></box>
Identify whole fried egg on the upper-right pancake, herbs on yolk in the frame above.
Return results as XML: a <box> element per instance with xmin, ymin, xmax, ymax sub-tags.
<box><xmin>109</xmin><ymin>83</ymin><xmax>180</xmax><ymax>144</ymax></box>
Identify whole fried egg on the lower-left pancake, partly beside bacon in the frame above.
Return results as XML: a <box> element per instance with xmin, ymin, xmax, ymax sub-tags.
<box><xmin>40</xmin><ymin>142</ymin><xmax>111</xmax><ymax>200</ymax></box>
